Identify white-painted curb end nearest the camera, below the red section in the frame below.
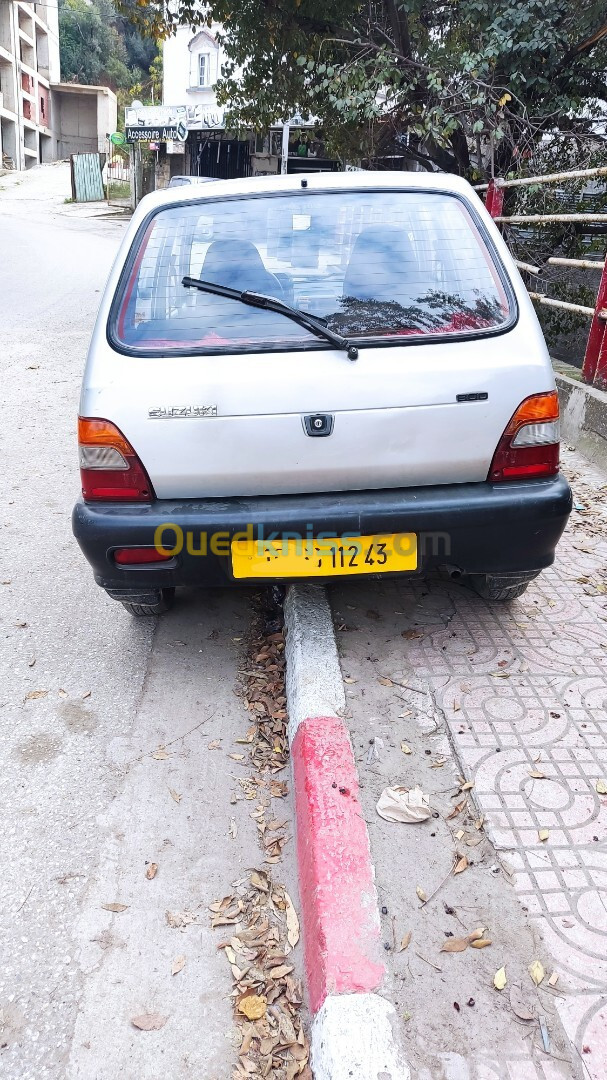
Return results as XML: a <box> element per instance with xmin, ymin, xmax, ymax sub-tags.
<box><xmin>311</xmin><ymin>994</ymin><xmax>410</xmax><ymax>1080</ymax></box>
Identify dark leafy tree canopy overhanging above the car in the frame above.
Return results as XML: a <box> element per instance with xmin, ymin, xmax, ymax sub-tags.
<box><xmin>117</xmin><ymin>0</ymin><xmax>607</xmax><ymax>175</ymax></box>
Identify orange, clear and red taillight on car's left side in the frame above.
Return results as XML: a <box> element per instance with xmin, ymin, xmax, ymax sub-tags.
<box><xmin>78</xmin><ymin>417</ymin><xmax>153</xmax><ymax>502</ymax></box>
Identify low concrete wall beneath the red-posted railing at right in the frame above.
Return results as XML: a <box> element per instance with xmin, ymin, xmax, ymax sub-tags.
<box><xmin>554</xmin><ymin>372</ymin><xmax>607</xmax><ymax>468</ymax></box>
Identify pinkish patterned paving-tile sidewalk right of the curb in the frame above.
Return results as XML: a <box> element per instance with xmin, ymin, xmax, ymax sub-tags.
<box><xmin>332</xmin><ymin>442</ymin><xmax>607</xmax><ymax>1080</ymax></box>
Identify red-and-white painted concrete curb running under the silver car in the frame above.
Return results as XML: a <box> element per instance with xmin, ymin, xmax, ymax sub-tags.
<box><xmin>285</xmin><ymin>585</ymin><xmax>410</xmax><ymax>1080</ymax></box>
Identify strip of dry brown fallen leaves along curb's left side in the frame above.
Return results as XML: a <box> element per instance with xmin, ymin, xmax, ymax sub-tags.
<box><xmin>210</xmin><ymin>595</ymin><xmax>312</xmax><ymax>1080</ymax></box>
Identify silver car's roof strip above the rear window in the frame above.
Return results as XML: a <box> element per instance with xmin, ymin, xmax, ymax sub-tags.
<box><xmin>135</xmin><ymin>170</ymin><xmax>481</xmax><ymax>219</ymax></box>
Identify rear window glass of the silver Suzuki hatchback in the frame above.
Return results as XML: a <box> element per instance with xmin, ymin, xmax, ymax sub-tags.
<box><xmin>110</xmin><ymin>189</ymin><xmax>511</xmax><ymax>354</ymax></box>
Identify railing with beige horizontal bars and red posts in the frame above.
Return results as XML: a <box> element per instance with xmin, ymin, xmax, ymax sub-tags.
<box><xmin>474</xmin><ymin>167</ymin><xmax>607</xmax><ymax>390</ymax></box>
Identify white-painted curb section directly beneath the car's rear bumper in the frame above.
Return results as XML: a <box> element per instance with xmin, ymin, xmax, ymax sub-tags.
<box><xmin>284</xmin><ymin>585</ymin><xmax>346</xmax><ymax>745</ymax></box>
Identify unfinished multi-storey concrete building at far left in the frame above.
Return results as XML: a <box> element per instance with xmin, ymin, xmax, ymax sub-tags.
<box><xmin>0</xmin><ymin>0</ymin><xmax>59</xmax><ymax>168</ymax></box>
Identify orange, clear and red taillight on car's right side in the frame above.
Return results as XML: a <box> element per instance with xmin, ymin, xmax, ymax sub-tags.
<box><xmin>488</xmin><ymin>390</ymin><xmax>561</xmax><ymax>481</ymax></box>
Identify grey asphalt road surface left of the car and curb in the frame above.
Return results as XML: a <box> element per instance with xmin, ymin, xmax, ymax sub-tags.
<box><xmin>0</xmin><ymin>165</ymin><xmax>296</xmax><ymax>1080</ymax></box>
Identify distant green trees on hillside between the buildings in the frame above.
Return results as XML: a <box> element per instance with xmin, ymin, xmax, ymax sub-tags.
<box><xmin>59</xmin><ymin>0</ymin><xmax>158</xmax><ymax>98</ymax></box>
